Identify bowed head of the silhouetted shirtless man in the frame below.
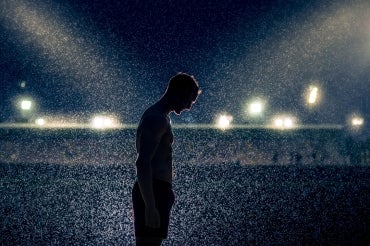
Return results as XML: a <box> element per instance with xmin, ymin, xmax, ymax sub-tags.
<box><xmin>165</xmin><ymin>73</ymin><xmax>201</xmax><ymax>114</ymax></box>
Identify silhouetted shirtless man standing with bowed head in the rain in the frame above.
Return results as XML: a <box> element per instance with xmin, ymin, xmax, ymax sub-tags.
<box><xmin>132</xmin><ymin>73</ymin><xmax>200</xmax><ymax>245</ymax></box>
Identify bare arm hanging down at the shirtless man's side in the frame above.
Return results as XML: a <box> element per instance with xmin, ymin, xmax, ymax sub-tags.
<box><xmin>136</xmin><ymin>115</ymin><xmax>167</xmax><ymax>228</ymax></box>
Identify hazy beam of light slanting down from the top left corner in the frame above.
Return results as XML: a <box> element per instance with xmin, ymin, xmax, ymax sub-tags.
<box><xmin>0</xmin><ymin>0</ymin><xmax>128</xmax><ymax>107</ymax></box>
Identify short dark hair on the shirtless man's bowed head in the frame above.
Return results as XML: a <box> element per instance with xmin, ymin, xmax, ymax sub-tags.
<box><xmin>166</xmin><ymin>73</ymin><xmax>201</xmax><ymax>101</ymax></box>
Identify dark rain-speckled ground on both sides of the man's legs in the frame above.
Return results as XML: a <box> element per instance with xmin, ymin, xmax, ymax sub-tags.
<box><xmin>0</xmin><ymin>163</ymin><xmax>370</xmax><ymax>245</ymax></box>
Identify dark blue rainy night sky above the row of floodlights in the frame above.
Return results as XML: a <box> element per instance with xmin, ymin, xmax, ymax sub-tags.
<box><xmin>0</xmin><ymin>0</ymin><xmax>370</xmax><ymax>135</ymax></box>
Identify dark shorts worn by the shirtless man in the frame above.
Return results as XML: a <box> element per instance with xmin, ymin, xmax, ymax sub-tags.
<box><xmin>132</xmin><ymin>180</ymin><xmax>175</xmax><ymax>238</ymax></box>
